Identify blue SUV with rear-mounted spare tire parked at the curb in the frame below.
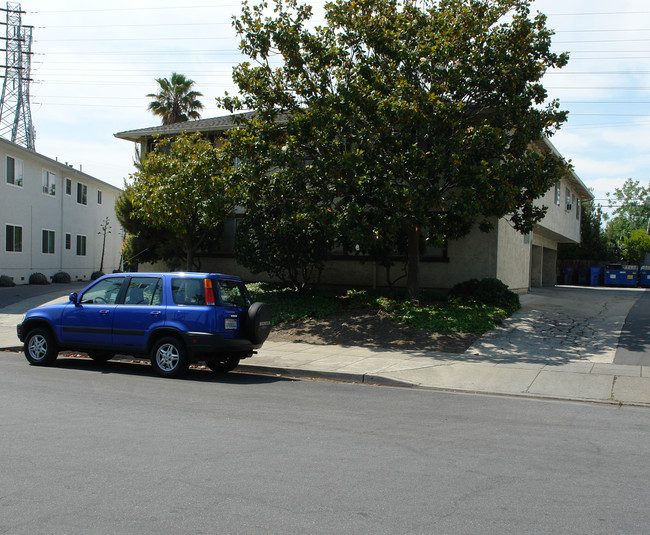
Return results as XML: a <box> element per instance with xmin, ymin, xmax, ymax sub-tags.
<box><xmin>17</xmin><ymin>273</ymin><xmax>271</xmax><ymax>377</ymax></box>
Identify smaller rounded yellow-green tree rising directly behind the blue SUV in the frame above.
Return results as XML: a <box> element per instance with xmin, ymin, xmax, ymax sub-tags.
<box><xmin>129</xmin><ymin>134</ymin><xmax>235</xmax><ymax>271</ymax></box>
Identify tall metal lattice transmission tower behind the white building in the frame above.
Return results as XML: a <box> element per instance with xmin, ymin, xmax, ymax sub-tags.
<box><xmin>0</xmin><ymin>2</ymin><xmax>36</xmax><ymax>150</ymax></box>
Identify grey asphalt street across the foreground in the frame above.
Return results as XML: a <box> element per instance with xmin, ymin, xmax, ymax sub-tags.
<box><xmin>0</xmin><ymin>353</ymin><xmax>650</xmax><ymax>535</ymax></box>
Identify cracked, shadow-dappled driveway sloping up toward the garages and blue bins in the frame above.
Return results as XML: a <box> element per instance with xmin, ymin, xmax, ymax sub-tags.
<box><xmin>467</xmin><ymin>286</ymin><xmax>650</xmax><ymax>365</ymax></box>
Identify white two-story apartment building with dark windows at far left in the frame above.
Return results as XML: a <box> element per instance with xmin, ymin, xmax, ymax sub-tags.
<box><xmin>0</xmin><ymin>138</ymin><xmax>123</xmax><ymax>284</ymax></box>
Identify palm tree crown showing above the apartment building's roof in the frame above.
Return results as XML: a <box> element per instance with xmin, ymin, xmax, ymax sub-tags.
<box><xmin>147</xmin><ymin>72</ymin><xmax>203</xmax><ymax>124</ymax></box>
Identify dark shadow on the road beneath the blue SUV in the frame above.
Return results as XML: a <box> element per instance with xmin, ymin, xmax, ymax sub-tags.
<box><xmin>53</xmin><ymin>355</ymin><xmax>296</xmax><ymax>385</ymax></box>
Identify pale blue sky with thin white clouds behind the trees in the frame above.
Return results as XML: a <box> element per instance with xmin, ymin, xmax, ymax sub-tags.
<box><xmin>12</xmin><ymin>0</ymin><xmax>650</xmax><ymax>211</ymax></box>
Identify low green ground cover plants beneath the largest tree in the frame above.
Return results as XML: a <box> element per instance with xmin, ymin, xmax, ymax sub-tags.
<box><xmin>248</xmin><ymin>279</ymin><xmax>519</xmax><ymax>334</ymax></box>
